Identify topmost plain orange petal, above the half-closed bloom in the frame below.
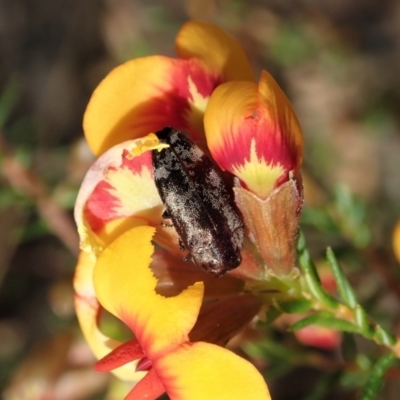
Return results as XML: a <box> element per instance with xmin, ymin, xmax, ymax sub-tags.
<box><xmin>175</xmin><ymin>21</ymin><xmax>254</xmax><ymax>82</ymax></box>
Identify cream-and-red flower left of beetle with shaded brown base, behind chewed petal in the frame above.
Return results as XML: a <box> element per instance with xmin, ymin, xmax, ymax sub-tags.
<box><xmin>74</xmin><ymin>135</ymin><xmax>260</xmax><ymax>380</ymax></box>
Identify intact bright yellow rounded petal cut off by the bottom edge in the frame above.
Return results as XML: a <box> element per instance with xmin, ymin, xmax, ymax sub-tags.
<box><xmin>154</xmin><ymin>342</ymin><xmax>271</xmax><ymax>400</ymax></box>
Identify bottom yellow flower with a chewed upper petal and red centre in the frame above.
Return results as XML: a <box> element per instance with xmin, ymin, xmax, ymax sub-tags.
<box><xmin>94</xmin><ymin>226</ymin><xmax>270</xmax><ymax>400</ymax></box>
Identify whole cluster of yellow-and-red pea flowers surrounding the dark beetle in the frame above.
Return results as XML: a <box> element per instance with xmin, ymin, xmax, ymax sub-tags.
<box><xmin>74</xmin><ymin>21</ymin><xmax>302</xmax><ymax>399</ymax></box>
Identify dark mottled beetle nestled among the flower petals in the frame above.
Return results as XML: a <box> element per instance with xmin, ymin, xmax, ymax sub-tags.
<box><xmin>152</xmin><ymin>127</ymin><xmax>244</xmax><ymax>276</ymax></box>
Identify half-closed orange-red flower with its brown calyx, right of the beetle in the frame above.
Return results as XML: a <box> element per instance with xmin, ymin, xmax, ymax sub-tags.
<box><xmin>204</xmin><ymin>71</ymin><xmax>303</xmax><ymax>276</ymax></box>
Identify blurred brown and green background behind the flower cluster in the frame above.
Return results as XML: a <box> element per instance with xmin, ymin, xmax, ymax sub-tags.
<box><xmin>0</xmin><ymin>0</ymin><xmax>400</xmax><ymax>400</ymax></box>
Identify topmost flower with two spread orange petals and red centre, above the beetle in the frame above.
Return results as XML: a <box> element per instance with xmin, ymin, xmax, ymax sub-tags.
<box><xmin>83</xmin><ymin>21</ymin><xmax>254</xmax><ymax>155</ymax></box>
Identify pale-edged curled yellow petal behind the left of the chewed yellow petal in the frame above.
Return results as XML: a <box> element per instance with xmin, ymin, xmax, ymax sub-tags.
<box><xmin>74</xmin><ymin>252</ymin><xmax>145</xmax><ymax>381</ymax></box>
